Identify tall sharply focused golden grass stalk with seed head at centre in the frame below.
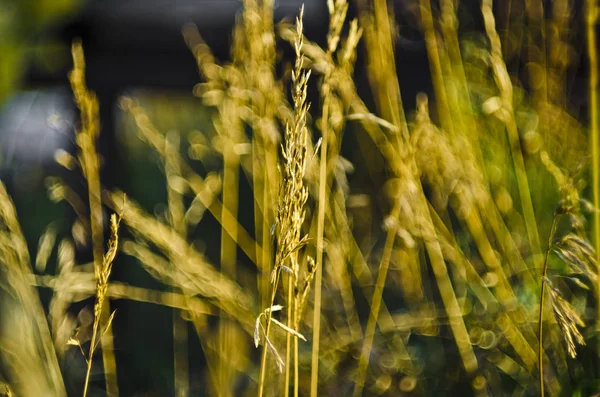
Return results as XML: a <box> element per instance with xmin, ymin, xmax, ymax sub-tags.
<box><xmin>255</xmin><ymin>7</ymin><xmax>310</xmax><ymax>396</ymax></box>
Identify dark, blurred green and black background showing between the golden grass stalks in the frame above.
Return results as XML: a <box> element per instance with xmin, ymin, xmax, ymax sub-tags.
<box><xmin>0</xmin><ymin>0</ymin><xmax>599</xmax><ymax>396</ymax></box>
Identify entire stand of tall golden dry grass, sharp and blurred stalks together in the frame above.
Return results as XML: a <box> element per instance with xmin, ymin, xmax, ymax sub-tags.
<box><xmin>0</xmin><ymin>0</ymin><xmax>599</xmax><ymax>396</ymax></box>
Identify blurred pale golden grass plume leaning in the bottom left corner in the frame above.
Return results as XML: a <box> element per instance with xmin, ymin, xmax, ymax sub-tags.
<box><xmin>0</xmin><ymin>182</ymin><xmax>66</xmax><ymax>397</ymax></box>
